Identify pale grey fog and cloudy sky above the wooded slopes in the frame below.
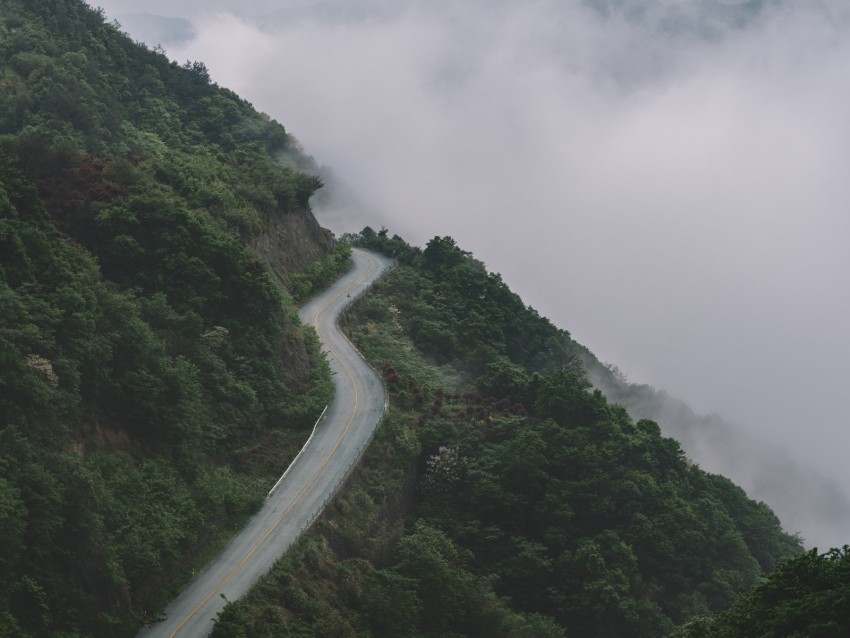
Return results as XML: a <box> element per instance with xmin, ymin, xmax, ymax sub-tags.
<box><xmin>99</xmin><ymin>0</ymin><xmax>850</xmax><ymax>543</ymax></box>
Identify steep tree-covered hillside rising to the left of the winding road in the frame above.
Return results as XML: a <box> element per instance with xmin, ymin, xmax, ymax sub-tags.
<box><xmin>0</xmin><ymin>0</ymin><xmax>348</xmax><ymax>637</ymax></box>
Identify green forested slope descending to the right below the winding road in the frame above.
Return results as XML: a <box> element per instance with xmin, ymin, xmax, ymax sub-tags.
<box><xmin>216</xmin><ymin>228</ymin><xmax>801</xmax><ymax>638</ymax></box>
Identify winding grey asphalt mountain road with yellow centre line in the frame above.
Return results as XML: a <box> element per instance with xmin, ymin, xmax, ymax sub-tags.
<box><xmin>139</xmin><ymin>248</ymin><xmax>391</xmax><ymax>638</ymax></box>
